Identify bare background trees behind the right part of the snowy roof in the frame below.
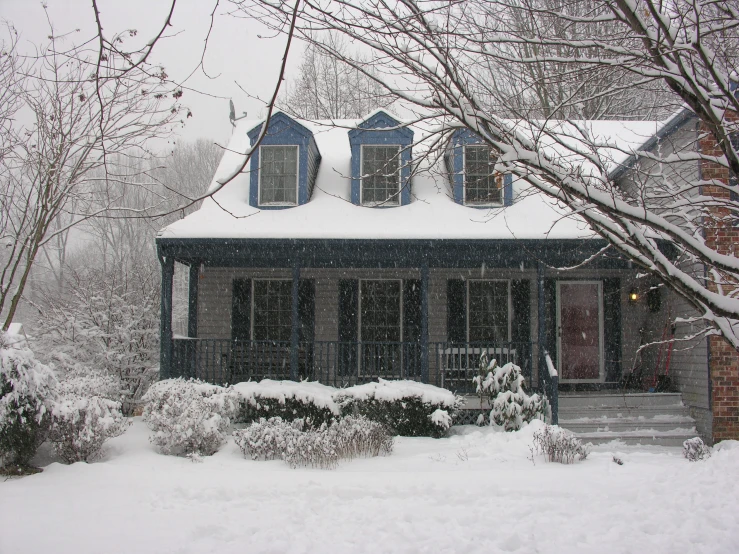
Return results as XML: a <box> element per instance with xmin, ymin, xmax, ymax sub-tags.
<box><xmin>486</xmin><ymin>0</ymin><xmax>670</xmax><ymax>120</ymax></box>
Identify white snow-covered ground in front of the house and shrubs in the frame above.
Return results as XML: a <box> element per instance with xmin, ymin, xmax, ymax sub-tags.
<box><xmin>0</xmin><ymin>419</ymin><xmax>739</xmax><ymax>554</ymax></box>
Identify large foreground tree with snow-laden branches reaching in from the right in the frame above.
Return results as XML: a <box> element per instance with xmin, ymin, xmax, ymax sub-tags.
<box><xmin>235</xmin><ymin>0</ymin><xmax>739</xmax><ymax>348</ymax></box>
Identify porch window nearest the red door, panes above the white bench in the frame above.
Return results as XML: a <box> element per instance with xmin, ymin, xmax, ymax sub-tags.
<box><xmin>467</xmin><ymin>281</ymin><xmax>509</xmax><ymax>343</ymax></box>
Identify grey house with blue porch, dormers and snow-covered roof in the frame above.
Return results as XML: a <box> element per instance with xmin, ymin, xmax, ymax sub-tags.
<box><xmin>157</xmin><ymin>111</ymin><xmax>728</xmax><ymax>436</ymax></box>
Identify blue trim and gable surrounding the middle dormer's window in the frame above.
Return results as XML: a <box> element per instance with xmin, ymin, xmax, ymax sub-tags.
<box><xmin>349</xmin><ymin>110</ymin><xmax>413</xmax><ymax>207</ymax></box>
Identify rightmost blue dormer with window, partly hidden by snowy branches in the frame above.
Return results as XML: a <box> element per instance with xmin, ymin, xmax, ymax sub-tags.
<box><xmin>444</xmin><ymin>129</ymin><xmax>513</xmax><ymax>208</ymax></box>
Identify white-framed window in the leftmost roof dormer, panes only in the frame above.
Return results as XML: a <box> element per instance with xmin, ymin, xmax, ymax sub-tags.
<box><xmin>259</xmin><ymin>146</ymin><xmax>298</xmax><ymax>204</ymax></box>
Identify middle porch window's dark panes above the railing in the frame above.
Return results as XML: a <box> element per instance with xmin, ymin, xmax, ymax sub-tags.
<box><xmin>360</xmin><ymin>281</ymin><xmax>401</xmax><ymax>342</ymax></box>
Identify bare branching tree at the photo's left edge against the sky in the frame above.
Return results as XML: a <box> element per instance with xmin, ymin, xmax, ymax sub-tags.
<box><xmin>0</xmin><ymin>16</ymin><xmax>182</xmax><ymax>329</ymax></box>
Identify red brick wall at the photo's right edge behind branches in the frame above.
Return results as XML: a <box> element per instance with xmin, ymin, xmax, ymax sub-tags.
<box><xmin>700</xmin><ymin>122</ymin><xmax>739</xmax><ymax>441</ymax></box>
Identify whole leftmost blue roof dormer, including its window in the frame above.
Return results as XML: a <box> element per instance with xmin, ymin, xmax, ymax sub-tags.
<box><xmin>248</xmin><ymin>112</ymin><xmax>321</xmax><ymax>210</ymax></box>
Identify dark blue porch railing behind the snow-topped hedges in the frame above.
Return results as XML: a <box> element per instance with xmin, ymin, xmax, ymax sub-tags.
<box><xmin>170</xmin><ymin>338</ymin><xmax>535</xmax><ymax>394</ymax></box>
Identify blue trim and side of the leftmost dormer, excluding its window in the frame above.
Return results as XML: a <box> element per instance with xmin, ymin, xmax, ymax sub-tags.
<box><xmin>247</xmin><ymin>112</ymin><xmax>321</xmax><ymax>210</ymax></box>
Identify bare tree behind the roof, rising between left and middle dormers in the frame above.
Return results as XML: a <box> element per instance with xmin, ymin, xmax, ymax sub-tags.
<box><xmin>278</xmin><ymin>35</ymin><xmax>394</xmax><ymax>119</ymax></box>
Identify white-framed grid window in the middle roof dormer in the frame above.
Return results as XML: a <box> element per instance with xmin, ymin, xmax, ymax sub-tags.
<box><xmin>362</xmin><ymin>144</ymin><xmax>400</xmax><ymax>205</ymax></box>
